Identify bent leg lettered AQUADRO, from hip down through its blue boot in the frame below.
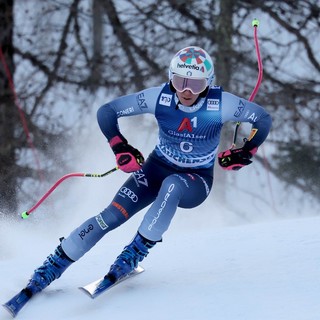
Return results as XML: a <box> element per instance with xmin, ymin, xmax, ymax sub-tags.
<box><xmin>108</xmin><ymin>174</ymin><xmax>212</xmax><ymax>280</ymax></box>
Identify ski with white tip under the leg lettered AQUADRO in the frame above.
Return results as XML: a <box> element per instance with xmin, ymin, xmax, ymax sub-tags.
<box><xmin>79</xmin><ymin>266</ymin><xmax>144</xmax><ymax>299</ymax></box>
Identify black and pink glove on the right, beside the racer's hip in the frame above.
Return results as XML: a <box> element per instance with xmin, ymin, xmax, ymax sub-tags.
<box><xmin>218</xmin><ymin>148</ymin><xmax>258</xmax><ymax>170</ymax></box>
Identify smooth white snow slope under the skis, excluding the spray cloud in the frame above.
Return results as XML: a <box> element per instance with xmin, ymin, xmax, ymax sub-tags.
<box><xmin>0</xmin><ymin>211</ymin><xmax>320</xmax><ymax>320</ymax></box>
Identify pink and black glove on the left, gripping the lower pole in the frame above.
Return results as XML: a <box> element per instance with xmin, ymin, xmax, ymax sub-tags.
<box><xmin>109</xmin><ymin>136</ymin><xmax>144</xmax><ymax>172</ymax></box>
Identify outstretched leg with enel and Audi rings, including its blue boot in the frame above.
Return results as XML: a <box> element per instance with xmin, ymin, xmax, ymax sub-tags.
<box><xmin>27</xmin><ymin>164</ymin><xmax>155</xmax><ymax>294</ymax></box>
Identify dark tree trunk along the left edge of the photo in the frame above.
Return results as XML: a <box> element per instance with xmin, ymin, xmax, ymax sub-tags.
<box><xmin>0</xmin><ymin>0</ymin><xmax>20</xmax><ymax>214</ymax></box>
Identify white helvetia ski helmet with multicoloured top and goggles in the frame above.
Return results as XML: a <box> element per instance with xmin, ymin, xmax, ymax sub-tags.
<box><xmin>169</xmin><ymin>46</ymin><xmax>214</xmax><ymax>94</ymax></box>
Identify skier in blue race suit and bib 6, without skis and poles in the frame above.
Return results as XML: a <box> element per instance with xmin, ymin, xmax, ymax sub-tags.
<box><xmin>7</xmin><ymin>46</ymin><xmax>271</xmax><ymax>304</ymax></box>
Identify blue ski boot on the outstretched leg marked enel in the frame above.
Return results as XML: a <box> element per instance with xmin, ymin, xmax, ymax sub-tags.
<box><xmin>25</xmin><ymin>245</ymin><xmax>74</xmax><ymax>296</ymax></box>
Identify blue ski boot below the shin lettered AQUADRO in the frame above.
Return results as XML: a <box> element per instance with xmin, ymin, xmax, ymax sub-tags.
<box><xmin>107</xmin><ymin>233</ymin><xmax>157</xmax><ymax>282</ymax></box>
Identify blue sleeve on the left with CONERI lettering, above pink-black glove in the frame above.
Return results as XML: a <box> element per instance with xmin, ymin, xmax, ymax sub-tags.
<box><xmin>97</xmin><ymin>87</ymin><xmax>162</xmax><ymax>141</ymax></box>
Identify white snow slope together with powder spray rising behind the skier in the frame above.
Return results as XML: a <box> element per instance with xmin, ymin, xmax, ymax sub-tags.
<box><xmin>0</xmin><ymin>119</ymin><xmax>320</xmax><ymax>320</ymax></box>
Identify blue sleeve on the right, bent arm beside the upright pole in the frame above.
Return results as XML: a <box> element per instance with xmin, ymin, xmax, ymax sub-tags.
<box><xmin>222</xmin><ymin>92</ymin><xmax>272</xmax><ymax>150</ymax></box>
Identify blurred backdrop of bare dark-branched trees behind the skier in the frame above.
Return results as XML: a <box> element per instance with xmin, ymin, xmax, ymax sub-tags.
<box><xmin>0</xmin><ymin>0</ymin><xmax>320</xmax><ymax>212</ymax></box>
